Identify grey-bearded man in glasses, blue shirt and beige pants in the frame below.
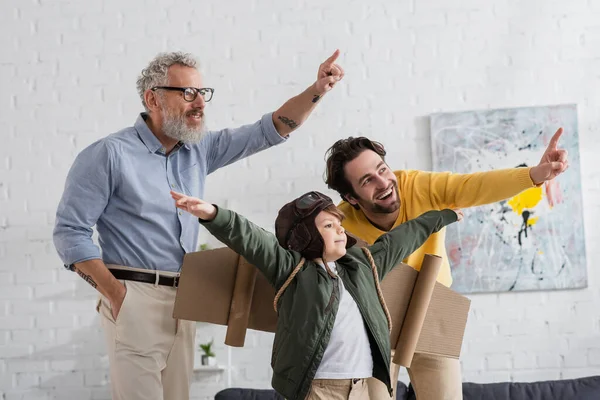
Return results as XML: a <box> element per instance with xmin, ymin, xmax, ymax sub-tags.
<box><xmin>54</xmin><ymin>51</ymin><xmax>344</xmax><ymax>400</ymax></box>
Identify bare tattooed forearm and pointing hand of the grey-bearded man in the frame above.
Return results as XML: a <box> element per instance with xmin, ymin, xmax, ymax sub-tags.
<box><xmin>273</xmin><ymin>50</ymin><xmax>344</xmax><ymax>137</ymax></box>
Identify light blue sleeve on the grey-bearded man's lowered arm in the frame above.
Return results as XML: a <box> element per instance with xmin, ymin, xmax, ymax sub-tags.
<box><xmin>53</xmin><ymin>140</ymin><xmax>116</xmax><ymax>269</ymax></box>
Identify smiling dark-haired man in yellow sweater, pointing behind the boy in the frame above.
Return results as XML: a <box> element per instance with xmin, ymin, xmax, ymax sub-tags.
<box><xmin>326</xmin><ymin>128</ymin><xmax>568</xmax><ymax>400</ymax></box>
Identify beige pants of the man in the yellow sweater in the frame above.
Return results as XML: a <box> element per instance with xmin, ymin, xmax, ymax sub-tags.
<box><xmin>367</xmin><ymin>353</ymin><xmax>463</xmax><ymax>400</ymax></box>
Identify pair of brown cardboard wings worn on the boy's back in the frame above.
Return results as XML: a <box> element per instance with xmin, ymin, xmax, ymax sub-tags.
<box><xmin>173</xmin><ymin>248</ymin><xmax>470</xmax><ymax>366</ymax></box>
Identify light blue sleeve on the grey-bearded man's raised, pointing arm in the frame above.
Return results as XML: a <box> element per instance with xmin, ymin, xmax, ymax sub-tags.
<box><xmin>203</xmin><ymin>113</ymin><xmax>287</xmax><ymax>174</ymax></box>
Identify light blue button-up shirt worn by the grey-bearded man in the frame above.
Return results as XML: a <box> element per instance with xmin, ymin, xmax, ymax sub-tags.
<box><xmin>54</xmin><ymin>114</ymin><xmax>285</xmax><ymax>272</ymax></box>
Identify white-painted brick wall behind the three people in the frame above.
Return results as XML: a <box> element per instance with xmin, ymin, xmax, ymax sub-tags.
<box><xmin>0</xmin><ymin>0</ymin><xmax>600</xmax><ymax>400</ymax></box>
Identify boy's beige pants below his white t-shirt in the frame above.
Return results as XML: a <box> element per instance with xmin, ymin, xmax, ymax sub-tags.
<box><xmin>306</xmin><ymin>379</ymin><xmax>369</xmax><ymax>400</ymax></box>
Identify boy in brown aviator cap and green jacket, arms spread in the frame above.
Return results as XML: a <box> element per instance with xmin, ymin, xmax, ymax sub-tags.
<box><xmin>171</xmin><ymin>192</ymin><xmax>462</xmax><ymax>400</ymax></box>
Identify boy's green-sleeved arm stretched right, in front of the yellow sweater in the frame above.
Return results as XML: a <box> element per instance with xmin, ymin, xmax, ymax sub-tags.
<box><xmin>369</xmin><ymin>209</ymin><xmax>463</xmax><ymax>279</ymax></box>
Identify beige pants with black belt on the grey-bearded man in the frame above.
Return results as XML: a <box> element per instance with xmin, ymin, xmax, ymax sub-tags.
<box><xmin>98</xmin><ymin>265</ymin><xmax>196</xmax><ymax>400</ymax></box>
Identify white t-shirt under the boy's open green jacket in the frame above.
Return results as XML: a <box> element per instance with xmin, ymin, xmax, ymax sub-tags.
<box><xmin>315</xmin><ymin>262</ymin><xmax>373</xmax><ymax>379</ymax></box>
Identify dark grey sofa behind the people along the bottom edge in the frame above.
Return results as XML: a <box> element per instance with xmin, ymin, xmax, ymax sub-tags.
<box><xmin>215</xmin><ymin>376</ymin><xmax>600</xmax><ymax>400</ymax></box>
